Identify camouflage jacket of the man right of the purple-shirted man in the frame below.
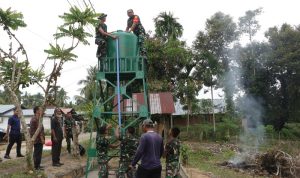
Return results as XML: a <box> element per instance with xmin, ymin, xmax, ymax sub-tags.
<box><xmin>165</xmin><ymin>138</ymin><xmax>180</xmax><ymax>163</ymax></box>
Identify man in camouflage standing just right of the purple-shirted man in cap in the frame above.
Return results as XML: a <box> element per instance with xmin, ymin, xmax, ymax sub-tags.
<box><xmin>164</xmin><ymin>127</ymin><xmax>180</xmax><ymax>178</ymax></box>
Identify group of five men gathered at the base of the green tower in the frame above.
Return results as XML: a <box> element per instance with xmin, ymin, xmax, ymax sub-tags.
<box><xmin>96</xmin><ymin>119</ymin><xmax>180</xmax><ymax>178</ymax></box>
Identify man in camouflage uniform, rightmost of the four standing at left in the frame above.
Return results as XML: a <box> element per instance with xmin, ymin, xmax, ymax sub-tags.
<box><xmin>64</xmin><ymin>111</ymin><xmax>76</xmax><ymax>153</ymax></box>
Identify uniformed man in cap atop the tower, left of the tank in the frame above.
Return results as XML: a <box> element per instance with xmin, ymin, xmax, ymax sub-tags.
<box><xmin>95</xmin><ymin>13</ymin><xmax>117</xmax><ymax>58</ymax></box>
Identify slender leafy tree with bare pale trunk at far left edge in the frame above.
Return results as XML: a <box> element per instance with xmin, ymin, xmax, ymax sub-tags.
<box><xmin>0</xmin><ymin>8</ymin><xmax>43</xmax><ymax>170</ymax></box>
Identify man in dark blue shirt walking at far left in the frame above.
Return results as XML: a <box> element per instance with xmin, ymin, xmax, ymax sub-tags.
<box><xmin>4</xmin><ymin>108</ymin><xmax>24</xmax><ymax>159</ymax></box>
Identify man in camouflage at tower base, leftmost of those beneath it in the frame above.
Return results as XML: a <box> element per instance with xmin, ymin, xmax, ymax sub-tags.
<box><xmin>96</xmin><ymin>125</ymin><xmax>118</xmax><ymax>178</ymax></box>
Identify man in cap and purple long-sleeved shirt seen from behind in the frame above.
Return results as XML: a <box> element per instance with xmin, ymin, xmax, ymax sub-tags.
<box><xmin>130</xmin><ymin>119</ymin><xmax>164</xmax><ymax>178</ymax></box>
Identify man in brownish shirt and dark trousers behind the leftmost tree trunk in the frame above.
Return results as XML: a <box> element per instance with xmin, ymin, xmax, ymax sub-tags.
<box><xmin>29</xmin><ymin>106</ymin><xmax>45</xmax><ymax>170</ymax></box>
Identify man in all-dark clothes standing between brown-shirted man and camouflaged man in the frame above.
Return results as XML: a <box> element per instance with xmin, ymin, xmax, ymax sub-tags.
<box><xmin>51</xmin><ymin>108</ymin><xmax>63</xmax><ymax>167</ymax></box>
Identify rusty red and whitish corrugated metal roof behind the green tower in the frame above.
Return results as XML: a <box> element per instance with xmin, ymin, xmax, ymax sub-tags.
<box><xmin>113</xmin><ymin>92</ymin><xmax>175</xmax><ymax>114</ymax></box>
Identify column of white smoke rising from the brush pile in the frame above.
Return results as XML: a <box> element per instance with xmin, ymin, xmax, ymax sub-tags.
<box><xmin>226</xmin><ymin>45</ymin><xmax>264</xmax><ymax>164</ymax></box>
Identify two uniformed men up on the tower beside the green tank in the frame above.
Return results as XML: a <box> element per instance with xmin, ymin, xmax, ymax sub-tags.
<box><xmin>95</xmin><ymin>9</ymin><xmax>146</xmax><ymax>58</ymax></box>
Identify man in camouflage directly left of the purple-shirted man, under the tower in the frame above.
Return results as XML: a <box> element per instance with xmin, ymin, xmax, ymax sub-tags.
<box><xmin>119</xmin><ymin>126</ymin><xmax>139</xmax><ymax>178</ymax></box>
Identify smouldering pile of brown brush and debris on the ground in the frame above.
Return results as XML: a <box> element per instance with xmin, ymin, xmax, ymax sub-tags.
<box><xmin>221</xmin><ymin>150</ymin><xmax>300</xmax><ymax>178</ymax></box>
